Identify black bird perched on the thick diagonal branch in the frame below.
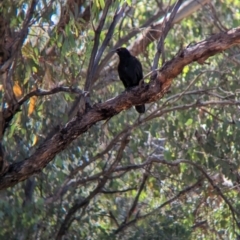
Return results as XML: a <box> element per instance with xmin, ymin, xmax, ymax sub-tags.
<box><xmin>116</xmin><ymin>48</ymin><xmax>145</xmax><ymax>113</ymax></box>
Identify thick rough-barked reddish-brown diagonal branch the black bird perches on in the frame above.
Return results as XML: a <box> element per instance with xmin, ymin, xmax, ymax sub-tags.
<box><xmin>0</xmin><ymin>27</ymin><xmax>240</xmax><ymax>189</ymax></box>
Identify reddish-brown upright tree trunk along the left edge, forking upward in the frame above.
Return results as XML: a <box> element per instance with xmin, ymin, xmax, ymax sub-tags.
<box><xmin>0</xmin><ymin>0</ymin><xmax>37</xmax><ymax>175</ymax></box>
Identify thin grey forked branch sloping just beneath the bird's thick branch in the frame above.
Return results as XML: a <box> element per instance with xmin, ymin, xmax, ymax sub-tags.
<box><xmin>45</xmin><ymin>84</ymin><xmax>231</xmax><ymax>203</ymax></box>
